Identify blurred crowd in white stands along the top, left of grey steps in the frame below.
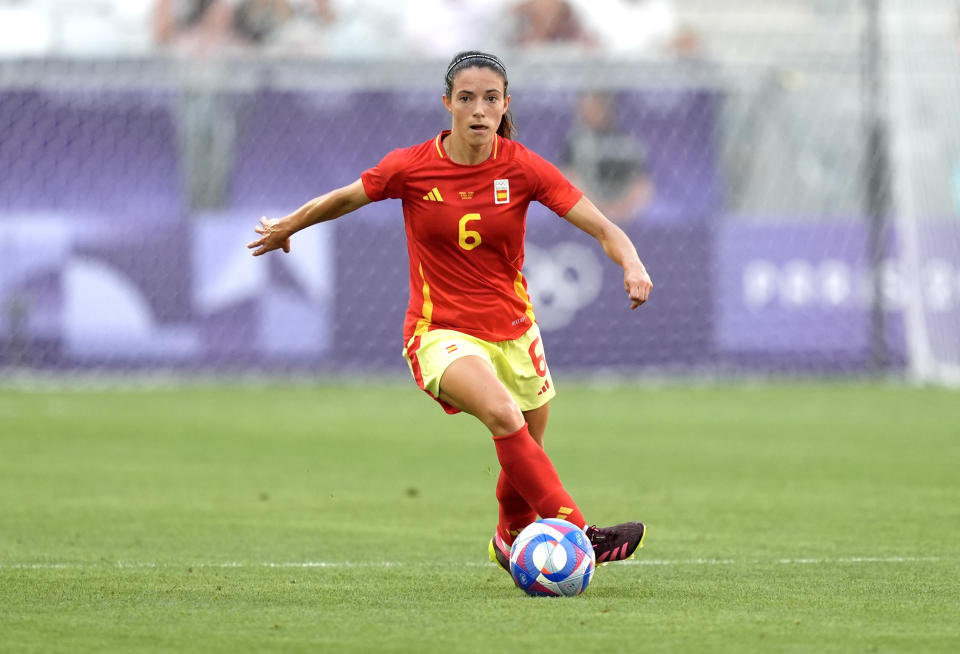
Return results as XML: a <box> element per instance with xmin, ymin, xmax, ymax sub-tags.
<box><xmin>0</xmin><ymin>0</ymin><xmax>696</xmax><ymax>59</ymax></box>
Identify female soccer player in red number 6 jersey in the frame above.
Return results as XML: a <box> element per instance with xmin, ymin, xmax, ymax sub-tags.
<box><xmin>248</xmin><ymin>51</ymin><xmax>653</xmax><ymax>571</ymax></box>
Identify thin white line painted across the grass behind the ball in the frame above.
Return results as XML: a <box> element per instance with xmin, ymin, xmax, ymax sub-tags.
<box><xmin>0</xmin><ymin>556</ymin><xmax>949</xmax><ymax>570</ymax></box>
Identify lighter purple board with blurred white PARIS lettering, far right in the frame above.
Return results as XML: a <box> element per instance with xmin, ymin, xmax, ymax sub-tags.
<box><xmin>713</xmin><ymin>216</ymin><xmax>960</xmax><ymax>372</ymax></box>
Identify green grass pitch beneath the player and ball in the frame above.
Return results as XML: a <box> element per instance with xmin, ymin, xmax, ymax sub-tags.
<box><xmin>0</xmin><ymin>379</ymin><xmax>960</xmax><ymax>653</ymax></box>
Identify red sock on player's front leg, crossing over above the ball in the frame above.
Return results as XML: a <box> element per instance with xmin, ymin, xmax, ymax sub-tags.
<box><xmin>493</xmin><ymin>423</ymin><xmax>587</xmax><ymax>539</ymax></box>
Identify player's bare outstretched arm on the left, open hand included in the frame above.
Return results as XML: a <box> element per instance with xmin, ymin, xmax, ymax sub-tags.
<box><xmin>247</xmin><ymin>179</ymin><xmax>371</xmax><ymax>257</ymax></box>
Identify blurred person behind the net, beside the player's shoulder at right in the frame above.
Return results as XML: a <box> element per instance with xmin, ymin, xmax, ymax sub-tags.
<box><xmin>563</xmin><ymin>91</ymin><xmax>653</xmax><ymax>224</ymax></box>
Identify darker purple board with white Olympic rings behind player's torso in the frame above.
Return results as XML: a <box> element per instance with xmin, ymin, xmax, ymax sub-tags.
<box><xmin>332</xmin><ymin>208</ymin><xmax>711</xmax><ymax>370</ymax></box>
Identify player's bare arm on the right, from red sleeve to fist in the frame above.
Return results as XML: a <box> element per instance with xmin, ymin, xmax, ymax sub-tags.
<box><xmin>564</xmin><ymin>196</ymin><xmax>653</xmax><ymax>309</ymax></box>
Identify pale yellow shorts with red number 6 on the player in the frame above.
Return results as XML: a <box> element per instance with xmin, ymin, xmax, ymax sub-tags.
<box><xmin>403</xmin><ymin>323</ymin><xmax>557</xmax><ymax>413</ymax></box>
